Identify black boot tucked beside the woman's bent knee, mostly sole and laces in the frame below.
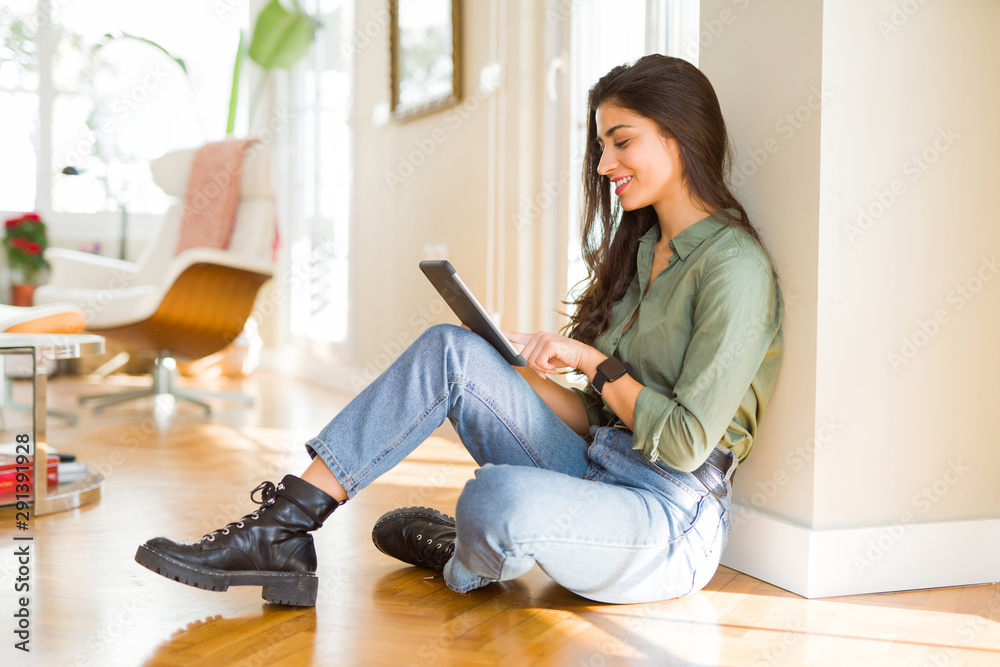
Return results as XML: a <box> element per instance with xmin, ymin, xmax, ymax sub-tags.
<box><xmin>372</xmin><ymin>507</ymin><xmax>456</xmax><ymax>572</ymax></box>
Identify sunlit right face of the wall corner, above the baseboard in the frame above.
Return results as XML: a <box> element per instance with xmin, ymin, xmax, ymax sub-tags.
<box><xmin>813</xmin><ymin>0</ymin><xmax>1000</xmax><ymax>528</ymax></box>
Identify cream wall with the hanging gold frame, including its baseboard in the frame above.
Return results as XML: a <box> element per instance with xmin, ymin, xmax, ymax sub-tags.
<box><xmin>282</xmin><ymin>0</ymin><xmax>545</xmax><ymax>391</ymax></box>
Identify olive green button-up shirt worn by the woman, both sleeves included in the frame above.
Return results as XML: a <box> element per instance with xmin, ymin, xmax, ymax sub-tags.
<box><xmin>576</xmin><ymin>211</ymin><xmax>784</xmax><ymax>471</ymax></box>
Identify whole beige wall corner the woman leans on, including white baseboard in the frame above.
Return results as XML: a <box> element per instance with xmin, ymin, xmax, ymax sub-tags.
<box><xmin>701</xmin><ymin>0</ymin><xmax>1000</xmax><ymax>595</ymax></box>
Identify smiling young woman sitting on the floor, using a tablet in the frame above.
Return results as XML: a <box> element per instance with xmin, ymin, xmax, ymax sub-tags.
<box><xmin>136</xmin><ymin>56</ymin><xmax>783</xmax><ymax>605</ymax></box>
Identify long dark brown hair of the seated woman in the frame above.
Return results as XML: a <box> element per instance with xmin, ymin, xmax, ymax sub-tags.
<box><xmin>563</xmin><ymin>55</ymin><xmax>764</xmax><ymax>345</ymax></box>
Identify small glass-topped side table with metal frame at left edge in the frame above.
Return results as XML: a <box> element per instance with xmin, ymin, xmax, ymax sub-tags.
<box><xmin>0</xmin><ymin>334</ymin><xmax>104</xmax><ymax>516</ymax></box>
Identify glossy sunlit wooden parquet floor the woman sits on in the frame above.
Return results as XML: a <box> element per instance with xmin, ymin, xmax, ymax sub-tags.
<box><xmin>0</xmin><ymin>373</ymin><xmax>1000</xmax><ymax>667</ymax></box>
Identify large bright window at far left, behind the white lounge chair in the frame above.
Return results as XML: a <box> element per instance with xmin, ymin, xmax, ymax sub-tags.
<box><xmin>0</xmin><ymin>0</ymin><xmax>249</xmax><ymax>231</ymax></box>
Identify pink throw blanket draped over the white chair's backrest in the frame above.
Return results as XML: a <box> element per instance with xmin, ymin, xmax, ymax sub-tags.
<box><xmin>174</xmin><ymin>139</ymin><xmax>255</xmax><ymax>254</ymax></box>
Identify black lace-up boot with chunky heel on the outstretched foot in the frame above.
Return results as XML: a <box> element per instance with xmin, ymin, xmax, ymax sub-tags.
<box><xmin>135</xmin><ymin>475</ymin><xmax>340</xmax><ymax>607</ymax></box>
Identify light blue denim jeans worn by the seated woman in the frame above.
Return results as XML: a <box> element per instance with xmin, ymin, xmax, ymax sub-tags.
<box><xmin>306</xmin><ymin>325</ymin><xmax>732</xmax><ymax>603</ymax></box>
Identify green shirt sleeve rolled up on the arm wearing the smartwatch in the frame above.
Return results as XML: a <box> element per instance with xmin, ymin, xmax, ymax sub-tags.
<box><xmin>633</xmin><ymin>252</ymin><xmax>783</xmax><ymax>472</ymax></box>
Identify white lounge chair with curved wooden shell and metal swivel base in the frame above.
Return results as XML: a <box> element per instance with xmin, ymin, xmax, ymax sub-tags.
<box><xmin>35</xmin><ymin>146</ymin><xmax>277</xmax><ymax>414</ymax></box>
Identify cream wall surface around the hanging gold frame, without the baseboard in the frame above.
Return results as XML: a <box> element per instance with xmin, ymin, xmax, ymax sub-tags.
<box><xmin>351</xmin><ymin>0</ymin><xmax>548</xmax><ymax>374</ymax></box>
